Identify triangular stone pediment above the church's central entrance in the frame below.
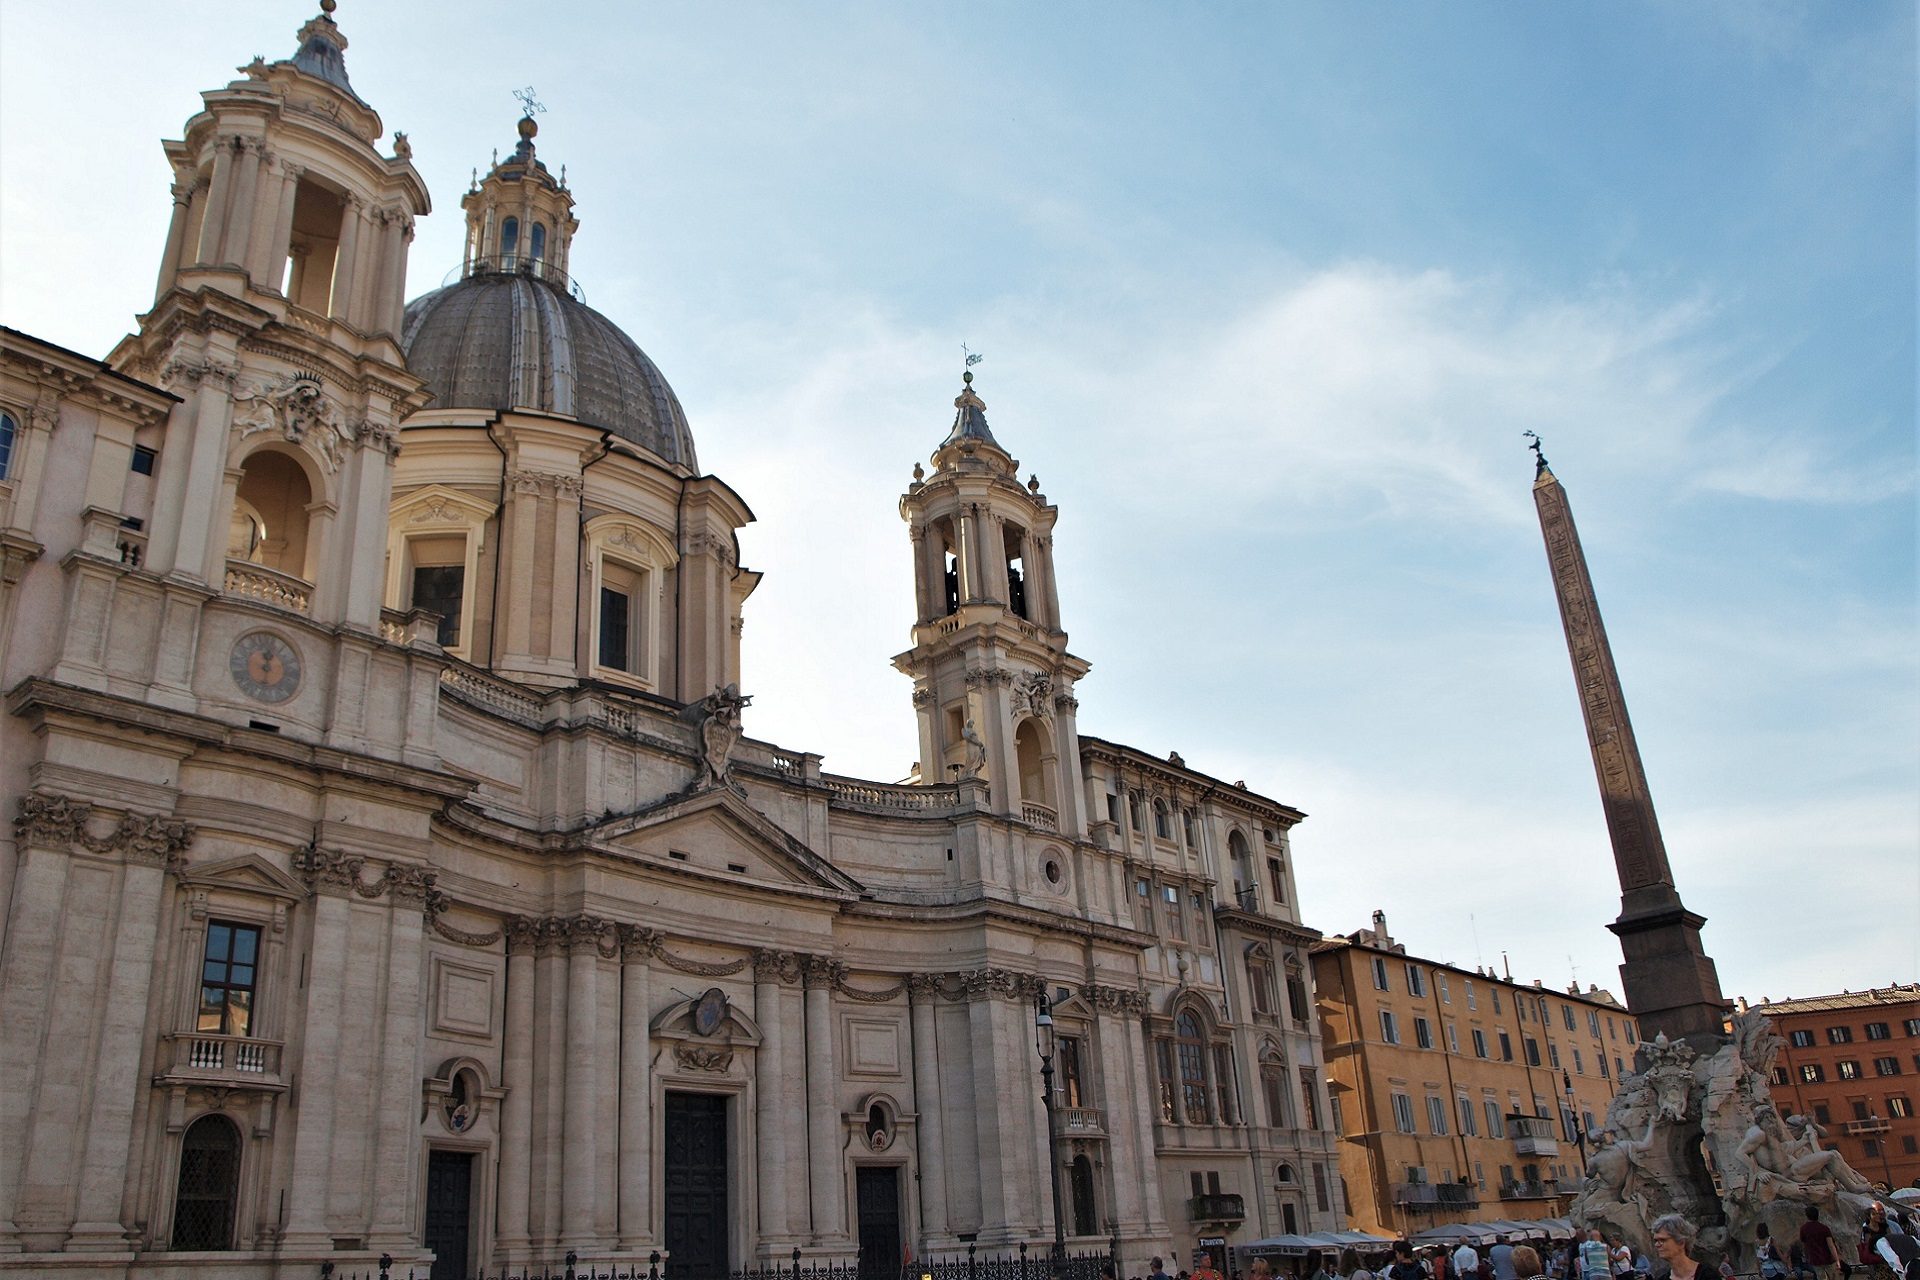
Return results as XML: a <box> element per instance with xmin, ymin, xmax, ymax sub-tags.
<box><xmin>584</xmin><ymin>787</ymin><xmax>862</xmax><ymax>896</ymax></box>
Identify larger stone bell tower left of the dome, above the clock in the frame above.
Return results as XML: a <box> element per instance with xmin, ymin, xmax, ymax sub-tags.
<box><xmin>108</xmin><ymin>0</ymin><xmax>430</xmax><ymax>631</ymax></box>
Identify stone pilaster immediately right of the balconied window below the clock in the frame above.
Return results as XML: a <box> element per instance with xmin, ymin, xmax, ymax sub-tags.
<box><xmin>284</xmin><ymin>848</ymin><xmax>355</xmax><ymax>1249</ymax></box>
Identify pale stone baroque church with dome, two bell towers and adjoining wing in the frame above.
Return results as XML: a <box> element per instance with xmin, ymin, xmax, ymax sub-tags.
<box><xmin>0</xmin><ymin>0</ymin><xmax>1344</xmax><ymax>1280</ymax></box>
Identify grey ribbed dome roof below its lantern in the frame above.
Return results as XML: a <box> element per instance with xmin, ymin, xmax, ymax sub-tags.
<box><xmin>399</xmin><ymin>273</ymin><xmax>699</xmax><ymax>470</ymax></box>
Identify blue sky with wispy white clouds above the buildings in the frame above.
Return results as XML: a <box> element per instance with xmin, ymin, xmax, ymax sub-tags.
<box><xmin>0</xmin><ymin>0</ymin><xmax>1920</xmax><ymax>998</ymax></box>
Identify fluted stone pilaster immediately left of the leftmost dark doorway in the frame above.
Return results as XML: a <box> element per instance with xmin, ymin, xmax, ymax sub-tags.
<box><xmin>369</xmin><ymin>865</ymin><xmax>436</xmax><ymax>1251</ymax></box>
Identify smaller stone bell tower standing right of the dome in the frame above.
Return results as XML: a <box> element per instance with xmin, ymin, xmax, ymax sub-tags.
<box><xmin>893</xmin><ymin>372</ymin><xmax>1089</xmax><ymax>837</ymax></box>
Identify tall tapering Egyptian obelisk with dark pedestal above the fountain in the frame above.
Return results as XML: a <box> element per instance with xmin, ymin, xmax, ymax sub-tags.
<box><xmin>1532</xmin><ymin>436</ymin><xmax>1726</xmax><ymax>1046</ymax></box>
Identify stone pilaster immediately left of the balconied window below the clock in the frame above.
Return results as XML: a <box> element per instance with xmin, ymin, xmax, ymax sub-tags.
<box><xmin>67</xmin><ymin>816</ymin><xmax>192</xmax><ymax>1251</ymax></box>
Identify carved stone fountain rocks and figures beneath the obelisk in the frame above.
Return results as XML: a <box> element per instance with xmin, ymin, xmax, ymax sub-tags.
<box><xmin>1571</xmin><ymin>1011</ymin><xmax>1872</xmax><ymax>1272</ymax></box>
